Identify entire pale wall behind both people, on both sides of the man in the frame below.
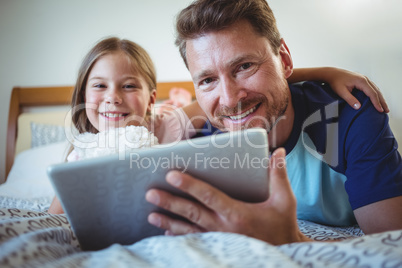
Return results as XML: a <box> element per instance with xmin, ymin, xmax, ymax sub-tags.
<box><xmin>0</xmin><ymin>0</ymin><xmax>402</xmax><ymax>182</ymax></box>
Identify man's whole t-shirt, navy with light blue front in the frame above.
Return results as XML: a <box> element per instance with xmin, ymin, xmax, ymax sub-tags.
<box><xmin>199</xmin><ymin>82</ymin><xmax>402</xmax><ymax>226</ymax></box>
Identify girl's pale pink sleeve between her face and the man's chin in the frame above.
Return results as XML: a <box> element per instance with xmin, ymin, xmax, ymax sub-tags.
<box><xmin>148</xmin><ymin>108</ymin><xmax>196</xmax><ymax>143</ymax></box>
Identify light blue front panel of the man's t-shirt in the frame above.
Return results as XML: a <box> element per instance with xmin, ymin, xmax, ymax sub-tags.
<box><xmin>286</xmin><ymin>133</ymin><xmax>356</xmax><ymax>226</ymax></box>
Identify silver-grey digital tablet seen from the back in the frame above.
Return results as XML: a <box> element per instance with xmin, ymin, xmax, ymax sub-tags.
<box><xmin>48</xmin><ymin>129</ymin><xmax>269</xmax><ymax>250</ymax></box>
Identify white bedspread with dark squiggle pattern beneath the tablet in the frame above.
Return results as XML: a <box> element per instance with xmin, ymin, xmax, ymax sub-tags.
<box><xmin>0</xmin><ymin>198</ymin><xmax>402</xmax><ymax>268</ymax></box>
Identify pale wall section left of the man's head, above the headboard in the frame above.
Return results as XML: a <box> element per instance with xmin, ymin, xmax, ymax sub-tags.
<box><xmin>0</xmin><ymin>0</ymin><xmax>195</xmax><ymax>182</ymax></box>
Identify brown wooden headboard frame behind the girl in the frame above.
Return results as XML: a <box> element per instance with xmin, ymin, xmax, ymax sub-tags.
<box><xmin>6</xmin><ymin>81</ymin><xmax>195</xmax><ymax>178</ymax></box>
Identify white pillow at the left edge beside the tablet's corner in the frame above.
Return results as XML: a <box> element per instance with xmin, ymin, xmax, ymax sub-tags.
<box><xmin>0</xmin><ymin>141</ymin><xmax>69</xmax><ymax>199</ymax></box>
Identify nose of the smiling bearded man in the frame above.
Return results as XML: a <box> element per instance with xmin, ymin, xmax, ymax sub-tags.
<box><xmin>219</xmin><ymin>79</ymin><xmax>247</xmax><ymax>108</ymax></box>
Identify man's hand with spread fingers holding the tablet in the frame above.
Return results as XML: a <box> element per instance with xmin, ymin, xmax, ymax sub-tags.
<box><xmin>146</xmin><ymin>148</ymin><xmax>308</xmax><ymax>245</ymax></box>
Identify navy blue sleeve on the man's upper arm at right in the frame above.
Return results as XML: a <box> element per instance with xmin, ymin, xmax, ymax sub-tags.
<box><xmin>343</xmin><ymin>91</ymin><xmax>402</xmax><ymax>209</ymax></box>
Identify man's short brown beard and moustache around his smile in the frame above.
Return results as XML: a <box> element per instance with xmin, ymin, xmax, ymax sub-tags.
<box><xmin>210</xmin><ymin>94</ymin><xmax>289</xmax><ymax>132</ymax></box>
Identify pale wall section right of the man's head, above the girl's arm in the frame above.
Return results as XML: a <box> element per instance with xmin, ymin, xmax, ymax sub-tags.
<box><xmin>268</xmin><ymin>0</ymin><xmax>402</xmax><ymax>149</ymax></box>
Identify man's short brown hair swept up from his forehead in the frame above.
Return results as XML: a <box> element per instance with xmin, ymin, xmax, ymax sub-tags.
<box><xmin>176</xmin><ymin>0</ymin><xmax>281</xmax><ymax>67</ymax></box>
